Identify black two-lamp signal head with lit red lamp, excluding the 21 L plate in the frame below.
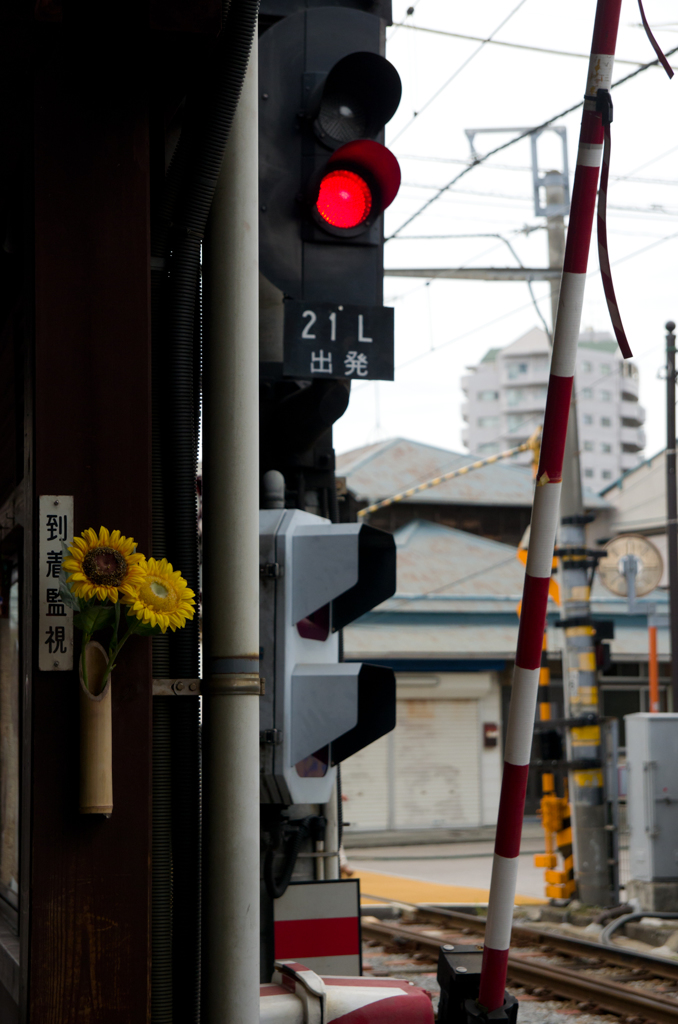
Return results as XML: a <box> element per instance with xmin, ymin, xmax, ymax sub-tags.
<box><xmin>259</xmin><ymin>6</ymin><xmax>401</xmax><ymax>306</ymax></box>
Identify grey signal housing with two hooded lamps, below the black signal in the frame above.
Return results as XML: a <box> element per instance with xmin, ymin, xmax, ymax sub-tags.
<box><xmin>260</xmin><ymin>509</ymin><xmax>395</xmax><ymax>805</ymax></box>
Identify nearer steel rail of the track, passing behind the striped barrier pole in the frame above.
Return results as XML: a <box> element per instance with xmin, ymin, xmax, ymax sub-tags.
<box><xmin>363</xmin><ymin>911</ymin><xmax>678</xmax><ymax>1024</ymax></box>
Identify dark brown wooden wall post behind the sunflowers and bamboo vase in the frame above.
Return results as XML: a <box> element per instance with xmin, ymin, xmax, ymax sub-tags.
<box><xmin>30</xmin><ymin>16</ymin><xmax>152</xmax><ymax>1024</ymax></box>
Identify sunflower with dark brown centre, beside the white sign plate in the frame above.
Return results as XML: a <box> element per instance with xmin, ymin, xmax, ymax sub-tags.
<box><xmin>63</xmin><ymin>526</ymin><xmax>143</xmax><ymax>604</ymax></box>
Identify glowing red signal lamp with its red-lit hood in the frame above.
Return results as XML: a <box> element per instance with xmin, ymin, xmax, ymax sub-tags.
<box><xmin>313</xmin><ymin>138</ymin><xmax>400</xmax><ymax>234</ymax></box>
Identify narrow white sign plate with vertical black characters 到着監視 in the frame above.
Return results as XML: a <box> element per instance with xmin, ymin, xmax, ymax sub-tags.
<box><xmin>38</xmin><ymin>495</ymin><xmax>73</xmax><ymax>672</ymax></box>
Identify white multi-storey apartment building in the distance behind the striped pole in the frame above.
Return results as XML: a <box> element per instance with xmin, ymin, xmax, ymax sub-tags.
<box><xmin>462</xmin><ymin>328</ymin><xmax>645</xmax><ymax>492</ymax></box>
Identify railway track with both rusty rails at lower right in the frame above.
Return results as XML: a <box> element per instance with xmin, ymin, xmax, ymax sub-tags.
<box><xmin>363</xmin><ymin>894</ymin><xmax>678</xmax><ymax>1024</ymax></box>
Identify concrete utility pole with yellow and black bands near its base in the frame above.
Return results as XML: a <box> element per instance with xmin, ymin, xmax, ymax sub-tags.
<box><xmin>546</xmin><ymin>175</ymin><xmax>615</xmax><ymax>906</ymax></box>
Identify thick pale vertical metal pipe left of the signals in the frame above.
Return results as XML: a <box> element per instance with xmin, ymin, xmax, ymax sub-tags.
<box><xmin>202</xmin><ymin>46</ymin><xmax>260</xmax><ymax>1024</ymax></box>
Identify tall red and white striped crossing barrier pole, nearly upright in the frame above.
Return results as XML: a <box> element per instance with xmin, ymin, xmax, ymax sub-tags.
<box><xmin>478</xmin><ymin>0</ymin><xmax>622</xmax><ymax>1011</ymax></box>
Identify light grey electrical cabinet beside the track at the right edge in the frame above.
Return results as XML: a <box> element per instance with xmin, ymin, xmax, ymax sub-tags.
<box><xmin>624</xmin><ymin>713</ymin><xmax>678</xmax><ymax>882</ymax></box>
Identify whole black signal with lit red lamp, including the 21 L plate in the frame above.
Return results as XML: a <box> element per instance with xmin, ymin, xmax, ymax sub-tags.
<box><xmin>259</xmin><ymin>0</ymin><xmax>401</xmax><ymax>508</ymax></box>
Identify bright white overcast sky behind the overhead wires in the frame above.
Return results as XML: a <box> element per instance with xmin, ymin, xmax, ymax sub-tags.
<box><xmin>335</xmin><ymin>0</ymin><xmax>678</xmax><ymax>464</ymax></box>
